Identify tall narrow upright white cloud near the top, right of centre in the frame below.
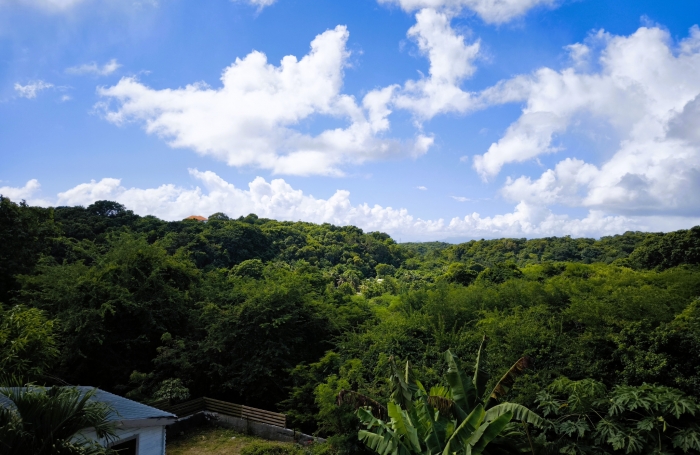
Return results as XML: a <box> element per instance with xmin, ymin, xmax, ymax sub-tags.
<box><xmin>393</xmin><ymin>8</ymin><xmax>480</xmax><ymax>120</ymax></box>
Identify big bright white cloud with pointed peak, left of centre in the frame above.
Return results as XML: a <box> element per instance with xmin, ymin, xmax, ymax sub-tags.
<box><xmin>99</xmin><ymin>26</ymin><xmax>433</xmax><ymax>175</ymax></box>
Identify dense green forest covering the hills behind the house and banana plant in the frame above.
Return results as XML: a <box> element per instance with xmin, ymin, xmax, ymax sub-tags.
<box><xmin>0</xmin><ymin>198</ymin><xmax>700</xmax><ymax>454</ymax></box>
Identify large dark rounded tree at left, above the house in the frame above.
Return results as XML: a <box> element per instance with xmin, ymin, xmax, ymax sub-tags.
<box><xmin>18</xmin><ymin>234</ymin><xmax>199</xmax><ymax>389</ymax></box>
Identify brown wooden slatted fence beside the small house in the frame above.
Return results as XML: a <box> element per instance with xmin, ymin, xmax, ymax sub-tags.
<box><xmin>152</xmin><ymin>397</ymin><xmax>287</xmax><ymax>428</ymax></box>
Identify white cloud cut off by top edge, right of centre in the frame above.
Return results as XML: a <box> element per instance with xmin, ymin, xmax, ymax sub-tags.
<box><xmin>378</xmin><ymin>0</ymin><xmax>555</xmax><ymax>24</ymax></box>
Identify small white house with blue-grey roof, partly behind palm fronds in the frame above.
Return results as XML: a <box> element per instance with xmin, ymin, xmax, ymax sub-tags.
<box><xmin>0</xmin><ymin>387</ymin><xmax>177</xmax><ymax>455</ymax></box>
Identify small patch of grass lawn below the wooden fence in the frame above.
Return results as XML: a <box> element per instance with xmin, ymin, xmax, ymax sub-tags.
<box><xmin>166</xmin><ymin>426</ymin><xmax>294</xmax><ymax>455</ymax></box>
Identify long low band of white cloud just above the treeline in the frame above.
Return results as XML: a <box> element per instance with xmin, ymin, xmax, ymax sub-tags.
<box><xmin>0</xmin><ymin>169</ymin><xmax>700</xmax><ymax>240</ymax></box>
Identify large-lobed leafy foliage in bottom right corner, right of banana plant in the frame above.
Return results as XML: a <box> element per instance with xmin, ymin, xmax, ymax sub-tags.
<box><xmin>537</xmin><ymin>378</ymin><xmax>700</xmax><ymax>454</ymax></box>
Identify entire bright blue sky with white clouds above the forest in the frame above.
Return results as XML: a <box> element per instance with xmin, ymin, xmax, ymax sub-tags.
<box><xmin>0</xmin><ymin>0</ymin><xmax>700</xmax><ymax>242</ymax></box>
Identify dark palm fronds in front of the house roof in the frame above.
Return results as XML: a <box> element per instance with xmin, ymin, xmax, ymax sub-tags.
<box><xmin>0</xmin><ymin>385</ymin><xmax>115</xmax><ymax>455</ymax></box>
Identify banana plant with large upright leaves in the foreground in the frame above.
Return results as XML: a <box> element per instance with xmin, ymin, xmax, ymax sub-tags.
<box><xmin>357</xmin><ymin>337</ymin><xmax>544</xmax><ymax>455</ymax></box>
